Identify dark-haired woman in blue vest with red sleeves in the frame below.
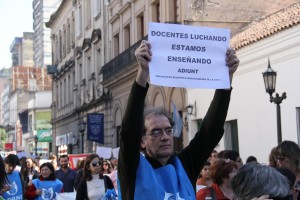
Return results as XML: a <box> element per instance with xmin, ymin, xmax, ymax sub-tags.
<box><xmin>25</xmin><ymin>162</ymin><xmax>63</xmax><ymax>200</ymax></box>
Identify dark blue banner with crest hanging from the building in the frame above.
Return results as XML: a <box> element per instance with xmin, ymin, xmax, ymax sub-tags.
<box><xmin>87</xmin><ymin>113</ymin><xmax>104</xmax><ymax>144</ymax></box>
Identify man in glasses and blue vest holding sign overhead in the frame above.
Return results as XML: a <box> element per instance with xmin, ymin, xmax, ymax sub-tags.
<box><xmin>118</xmin><ymin>33</ymin><xmax>239</xmax><ymax>200</ymax></box>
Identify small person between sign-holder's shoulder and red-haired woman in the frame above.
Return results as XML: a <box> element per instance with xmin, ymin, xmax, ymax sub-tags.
<box><xmin>196</xmin><ymin>161</ymin><xmax>213</xmax><ymax>192</ymax></box>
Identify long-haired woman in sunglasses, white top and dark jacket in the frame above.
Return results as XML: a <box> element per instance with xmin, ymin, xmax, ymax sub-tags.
<box><xmin>76</xmin><ymin>154</ymin><xmax>114</xmax><ymax>200</ymax></box>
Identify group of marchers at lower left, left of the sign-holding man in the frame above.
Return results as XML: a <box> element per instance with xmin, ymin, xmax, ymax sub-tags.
<box><xmin>0</xmin><ymin>154</ymin><xmax>117</xmax><ymax>200</ymax></box>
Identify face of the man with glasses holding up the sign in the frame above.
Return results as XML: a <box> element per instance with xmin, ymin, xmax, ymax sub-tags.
<box><xmin>142</xmin><ymin>114</ymin><xmax>173</xmax><ymax>164</ymax></box>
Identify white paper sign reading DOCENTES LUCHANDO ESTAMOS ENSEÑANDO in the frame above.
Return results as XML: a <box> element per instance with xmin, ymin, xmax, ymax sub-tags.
<box><xmin>148</xmin><ymin>22</ymin><xmax>230</xmax><ymax>89</ymax></box>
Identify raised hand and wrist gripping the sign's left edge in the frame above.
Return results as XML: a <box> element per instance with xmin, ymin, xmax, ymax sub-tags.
<box><xmin>135</xmin><ymin>40</ymin><xmax>152</xmax><ymax>87</ymax></box>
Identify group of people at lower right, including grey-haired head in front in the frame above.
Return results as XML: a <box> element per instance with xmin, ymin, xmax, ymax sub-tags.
<box><xmin>196</xmin><ymin>146</ymin><xmax>300</xmax><ymax>200</ymax></box>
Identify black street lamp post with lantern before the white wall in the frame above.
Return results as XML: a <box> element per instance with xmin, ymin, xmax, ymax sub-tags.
<box><xmin>263</xmin><ymin>59</ymin><xmax>286</xmax><ymax>144</ymax></box>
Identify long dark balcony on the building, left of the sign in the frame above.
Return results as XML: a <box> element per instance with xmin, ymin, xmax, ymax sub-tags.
<box><xmin>101</xmin><ymin>36</ymin><xmax>148</xmax><ymax>81</ymax></box>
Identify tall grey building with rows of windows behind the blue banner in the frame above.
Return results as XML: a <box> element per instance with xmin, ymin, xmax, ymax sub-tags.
<box><xmin>46</xmin><ymin>0</ymin><xmax>110</xmax><ymax>154</ymax></box>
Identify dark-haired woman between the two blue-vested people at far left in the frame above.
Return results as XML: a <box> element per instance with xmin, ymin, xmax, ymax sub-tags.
<box><xmin>21</xmin><ymin>158</ymin><xmax>39</xmax><ymax>190</ymax></box>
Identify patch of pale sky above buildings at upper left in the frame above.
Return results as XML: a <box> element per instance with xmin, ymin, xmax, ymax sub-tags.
<box><xmin>0</xmin><ymin>0</ymin><xmax>33</xmax><ymax>69</ymax></box>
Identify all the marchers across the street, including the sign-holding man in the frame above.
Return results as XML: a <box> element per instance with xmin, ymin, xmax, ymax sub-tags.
<box><xmin>0</xmin><ymin>41</ymin><xmax>300</xmax><ymax>200</ymax></box>
